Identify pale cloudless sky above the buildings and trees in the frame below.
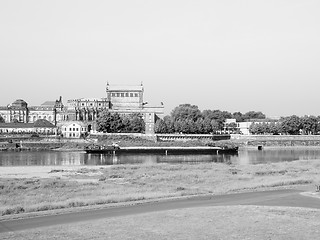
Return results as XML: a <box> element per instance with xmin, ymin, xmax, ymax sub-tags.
<box><xmin>0</xmin><ymin>0</ymin><xmax>320</xmax><ymax>117</ymax></box>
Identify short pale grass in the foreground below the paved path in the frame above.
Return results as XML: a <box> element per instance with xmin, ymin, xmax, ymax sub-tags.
<box><xmin>1</xmin><ymin>206</ymin><xmax>320</xmax><ymax>240</ymax></box>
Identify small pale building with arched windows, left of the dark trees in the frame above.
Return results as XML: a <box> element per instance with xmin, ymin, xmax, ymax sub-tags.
<box><xmin>60</xmin><ymin>121</ymin><xmax>88</xmax><ymax>138</ymax></box>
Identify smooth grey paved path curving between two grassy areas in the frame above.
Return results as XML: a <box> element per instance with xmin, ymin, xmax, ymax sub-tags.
<box><xmin>0</xmin><ymin>189</ymin><xmax>320</xmax><ymax>233</ymax></box>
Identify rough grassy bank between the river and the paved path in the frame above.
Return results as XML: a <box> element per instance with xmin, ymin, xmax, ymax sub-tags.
<box><xmin>0</xmin><ymin>161</ymin><xmax>320</xmax><ymax>218</ymax></box>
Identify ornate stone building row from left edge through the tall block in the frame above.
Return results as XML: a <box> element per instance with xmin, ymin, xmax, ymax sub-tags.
<box><xmin>0</xmin><ymin>83</ymin><xmax>164</xmax><ymax>137</ymax></box>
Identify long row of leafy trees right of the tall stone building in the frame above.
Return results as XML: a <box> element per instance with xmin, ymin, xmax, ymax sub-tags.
<box><xmin>155</xmin><ymin>104</ymin><xmax>320</xmax><ymax>135</ymax></box>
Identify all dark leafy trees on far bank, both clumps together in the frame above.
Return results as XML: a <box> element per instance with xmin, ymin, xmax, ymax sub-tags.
<box><xmin>70</xmin><ymin>104</ymin><xmax>320</xmax><ymax>135</ymax></box>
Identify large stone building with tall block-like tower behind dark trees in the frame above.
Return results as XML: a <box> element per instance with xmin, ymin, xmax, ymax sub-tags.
<box><xmin>62</xmin><ymin>83</ymin><xmax>164</xmax><ymax>134</ymax></box>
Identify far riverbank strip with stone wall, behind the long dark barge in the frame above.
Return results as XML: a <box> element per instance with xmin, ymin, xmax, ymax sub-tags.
<box><xmin>0</xmin><ymin>134</ymin><xmax>320</xmax><ymax>151</ymax></box>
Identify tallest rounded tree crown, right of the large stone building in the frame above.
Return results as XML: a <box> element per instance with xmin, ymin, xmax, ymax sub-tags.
<box><xmin>171</xmin><ymin>104</ymin><xmax>202</xmax><ymax>121</ymax></box>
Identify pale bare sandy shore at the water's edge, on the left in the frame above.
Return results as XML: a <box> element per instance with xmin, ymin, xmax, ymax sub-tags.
<box><xmin>0</xmin><ymin>165</ymin><xmax>110</xmax><ymax>178</ymax></box>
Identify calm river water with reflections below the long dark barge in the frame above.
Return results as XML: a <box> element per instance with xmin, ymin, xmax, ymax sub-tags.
<box><xmin>0</xmin><ymin>147</ymin><xmax>320</xmax><ymax>166</ymax></box>
